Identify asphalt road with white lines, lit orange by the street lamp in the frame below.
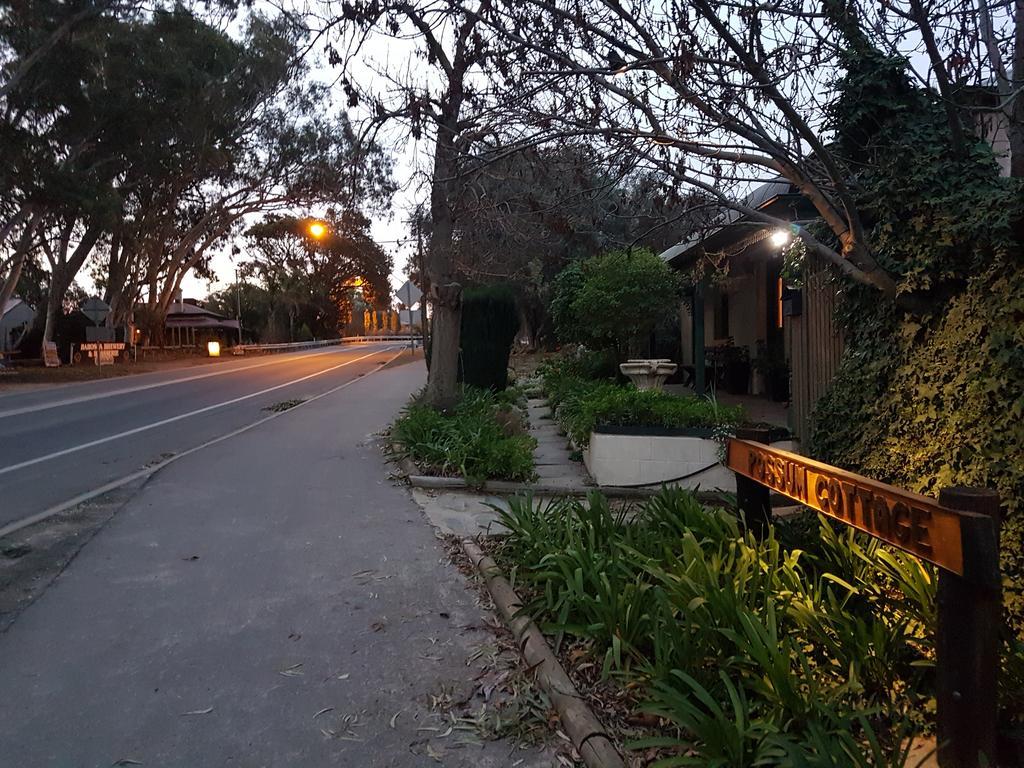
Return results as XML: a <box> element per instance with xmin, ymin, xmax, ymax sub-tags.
<box><xmin>0</xmin><ymin>342</ymin><xmax>401</xmax><ymax>529</ymax></box>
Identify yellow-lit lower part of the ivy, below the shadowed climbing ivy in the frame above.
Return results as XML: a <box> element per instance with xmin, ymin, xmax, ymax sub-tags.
<box><xmin>812</xmin><ymin>267</ymin><xmax>1024</xmax><ymax>638</ymax></box>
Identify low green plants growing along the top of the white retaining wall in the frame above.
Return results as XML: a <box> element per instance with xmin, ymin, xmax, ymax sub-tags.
<box><xmin>543</xmin><ymin>359</ymin><xmax>743</xmax><ymax>446</ymax></box>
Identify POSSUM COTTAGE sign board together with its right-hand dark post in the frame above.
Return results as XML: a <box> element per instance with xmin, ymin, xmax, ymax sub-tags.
<box><xmin>727</xmin><ymin>439</ymin><xmax>1002</xmax><ymax>768</ymax></box>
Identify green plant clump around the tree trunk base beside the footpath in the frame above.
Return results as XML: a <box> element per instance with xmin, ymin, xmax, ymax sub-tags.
<box><xmin>391</xmin><ymin>387</ymin><xmax>537</xmax><ymax>484</ymax></box>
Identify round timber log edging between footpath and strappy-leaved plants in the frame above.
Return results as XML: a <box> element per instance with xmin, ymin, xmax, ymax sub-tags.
<box><xmin>461</xmin><ymin>539</ymin><xmax>626</xmax><ymax>768</ymax></box>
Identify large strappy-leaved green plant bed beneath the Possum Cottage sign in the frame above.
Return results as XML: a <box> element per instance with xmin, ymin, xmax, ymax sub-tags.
<box><xmin>487</xmin><ymin>489</ymin><xmax>950</xmax><ymax>768</ymax></box>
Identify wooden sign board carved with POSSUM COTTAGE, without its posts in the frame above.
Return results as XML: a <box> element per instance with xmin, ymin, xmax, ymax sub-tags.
<box><xmin>727</xmin><ymin>438</ymin><xmax>991</xmax><ymax>581</ymax></box>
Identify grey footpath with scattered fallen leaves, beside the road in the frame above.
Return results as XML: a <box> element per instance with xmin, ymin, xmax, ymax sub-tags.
<box><xmin>0</xmin><ymin>361</ymin><xmax>552</xmax><ymax>768</ymax></box>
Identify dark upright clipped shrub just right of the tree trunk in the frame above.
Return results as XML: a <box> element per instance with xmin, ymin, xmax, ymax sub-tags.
<box><xmin>462</xmin><ymin>285</ymin><xmax>519</xmax><ymax>392</ymax></box>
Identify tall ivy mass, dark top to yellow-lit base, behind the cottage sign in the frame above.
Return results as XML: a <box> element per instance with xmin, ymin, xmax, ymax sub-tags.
<box><xmin>806</xmin><ymin>46</ymin><xmax>1024</xmax><ymax>638</ymax></box>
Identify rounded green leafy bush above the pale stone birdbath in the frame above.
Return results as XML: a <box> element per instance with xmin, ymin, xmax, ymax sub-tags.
<box><xmin>552</xmin><ymin>249</ymin><xmax>682</xmax><ymax>359</ymax></box>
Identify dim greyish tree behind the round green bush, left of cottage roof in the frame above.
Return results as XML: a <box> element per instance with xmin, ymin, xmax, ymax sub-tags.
<box><xmin>455</xmin><ymin>145</ymin><xmax>694</xmax><ymax>348</ymax></box>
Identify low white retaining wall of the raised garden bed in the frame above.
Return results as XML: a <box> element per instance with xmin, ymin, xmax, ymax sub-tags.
<box><xmin>583</xmin><ymin>432</ymin><xmax>797</xmax><ymax>493</ymax></box>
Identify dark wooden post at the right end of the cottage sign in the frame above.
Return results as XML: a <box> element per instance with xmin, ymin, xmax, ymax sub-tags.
<box><xmin>935</xmin><ymin>487</ymin><xmax>1002</xmax><ymax>768</ymax></box>
